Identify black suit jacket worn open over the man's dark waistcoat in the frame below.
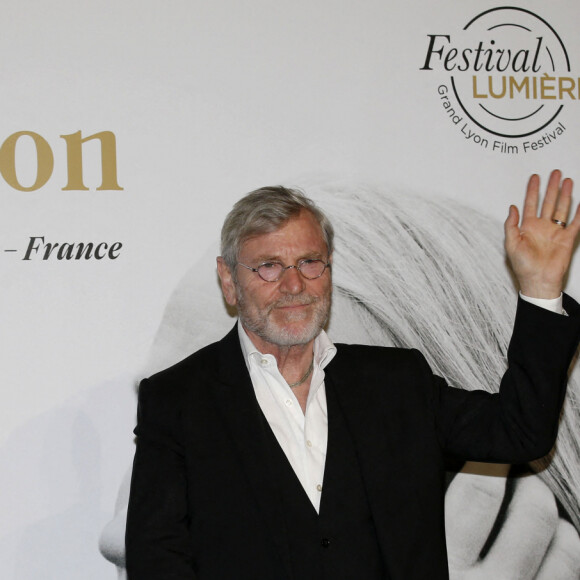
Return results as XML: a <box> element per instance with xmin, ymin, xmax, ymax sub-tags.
<box><xmin>126</xmin><ymin>298</ymin><xmax>580</xmax><ymax>580</ymax></box>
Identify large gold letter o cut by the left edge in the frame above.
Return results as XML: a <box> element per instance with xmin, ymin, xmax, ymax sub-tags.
<box><xmin>0</xmin><ymin>131</ymin><xmax>54</xmax><ymax>191</ymax></box>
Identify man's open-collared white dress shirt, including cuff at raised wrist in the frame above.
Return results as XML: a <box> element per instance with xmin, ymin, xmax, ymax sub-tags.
<box><xmin>238</xmin><ymin>294</ymin><xmax>565</xmax><ymax>512</ymax></box>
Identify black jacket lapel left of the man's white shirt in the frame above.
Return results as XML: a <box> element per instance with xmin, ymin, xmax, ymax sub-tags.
<box><xmin>214</xmin><ymin>326</ymin><xmax>292</xmax><ymax>578</ymax></box>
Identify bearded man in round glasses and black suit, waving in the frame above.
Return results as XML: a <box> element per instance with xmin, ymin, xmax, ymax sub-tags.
<box><xmin>127</xmin><ymin>172</ymin><xmax>580</xmax><ymax>580</ymax></box>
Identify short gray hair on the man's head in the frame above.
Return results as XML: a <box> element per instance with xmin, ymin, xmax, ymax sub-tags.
<box><xmin>221</xmin><ymin>185</ymin><xmax>334</xmax><ymax>276</ymax></box>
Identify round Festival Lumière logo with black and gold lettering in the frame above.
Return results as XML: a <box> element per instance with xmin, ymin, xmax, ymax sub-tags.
<box><xmin>421</xmin><ymin>7</ymin><xmax>580</xmax><ymax>154</ymax></box>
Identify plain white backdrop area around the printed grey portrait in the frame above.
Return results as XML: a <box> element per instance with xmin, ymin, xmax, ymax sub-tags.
<box><xmin>0</xmin><ymin>0</ymin><xmax>580</xmax><ymax>580</ymax></box>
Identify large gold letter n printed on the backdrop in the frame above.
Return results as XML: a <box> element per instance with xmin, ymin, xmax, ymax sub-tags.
<box><xmin>61</xmin><ymin>131</ymin><xmax>123</xmax><ymax>191</ymax></box>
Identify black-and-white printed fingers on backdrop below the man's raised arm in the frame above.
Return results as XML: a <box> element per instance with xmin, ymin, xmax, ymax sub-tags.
<box><xmin>445</xmin><ymin>472</ymin><xmax>580</xmax><ymax>580</ymax></box>
